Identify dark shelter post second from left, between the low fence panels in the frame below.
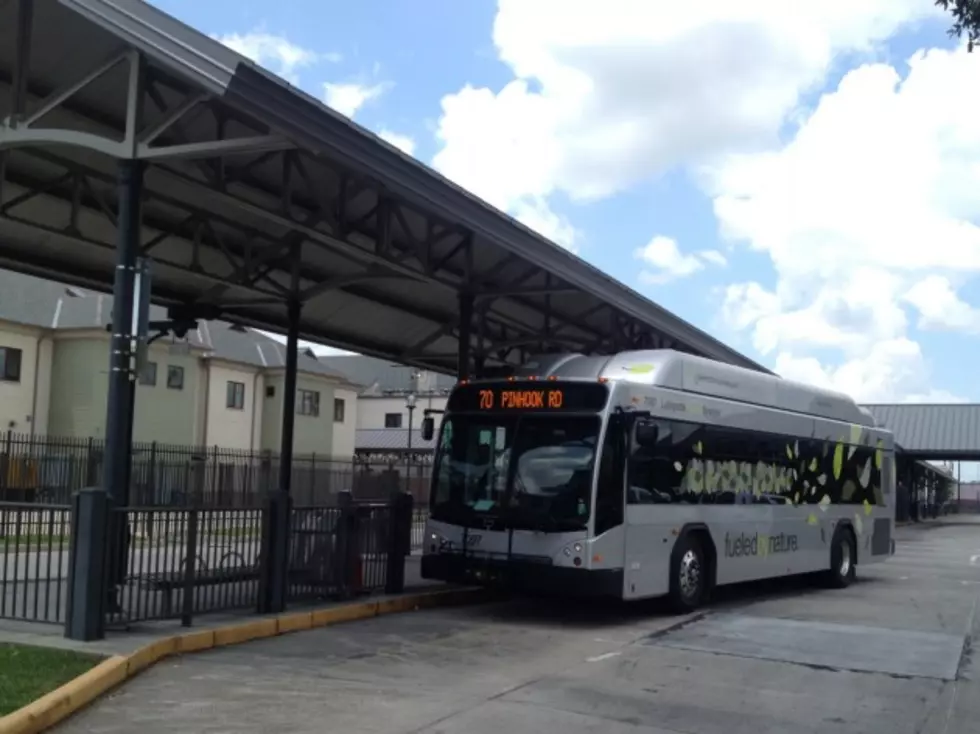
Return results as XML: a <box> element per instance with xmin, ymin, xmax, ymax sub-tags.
<box><xmin>260</xmin><ymin>296</ymin><xmax>302</xmax><ymax>614</ymax></box>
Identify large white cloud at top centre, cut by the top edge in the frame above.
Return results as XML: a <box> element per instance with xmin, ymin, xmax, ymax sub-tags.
<box><xmin>433</xmin><ymin>0</ymin><xmax>939</xmax><ymax>247</ymax></box>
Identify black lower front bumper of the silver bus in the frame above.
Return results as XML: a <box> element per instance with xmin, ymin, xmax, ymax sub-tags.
<box><xmin>422</xmin><ymin>553</ymin><xmax>623</xmax><ymax>598</ymax></box>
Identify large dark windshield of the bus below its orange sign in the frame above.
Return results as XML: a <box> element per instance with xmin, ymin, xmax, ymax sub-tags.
<box><xmin>431</xmin><ymin>414</ymin><xmax>599</xmax><ymax>532</ymax></box>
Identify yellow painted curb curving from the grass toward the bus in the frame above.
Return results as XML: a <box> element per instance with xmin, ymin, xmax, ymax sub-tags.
<box><xmin>0</xmin><ymin>589</ymin><xmax>490</xmax><ymax>734</ymax></box>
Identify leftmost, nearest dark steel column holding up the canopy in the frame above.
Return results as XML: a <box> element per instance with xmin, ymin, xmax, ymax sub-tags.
<box><xmin>103</xmin><ymin>160</ymin><xmax>143</xmax><ymax>612</ymax></box>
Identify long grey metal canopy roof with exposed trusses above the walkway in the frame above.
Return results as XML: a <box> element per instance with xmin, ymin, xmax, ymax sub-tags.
<box><xmin>0</xmin><ymin>0</ymin><xmax>767</xmax><ymax>372</ymax></box>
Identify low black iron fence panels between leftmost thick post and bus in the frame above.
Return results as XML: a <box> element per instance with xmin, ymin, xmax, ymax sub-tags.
<box><xmin>105</xmin><ymin>493</ymin><xmax>415</xmax><ymax>625</ymax></box>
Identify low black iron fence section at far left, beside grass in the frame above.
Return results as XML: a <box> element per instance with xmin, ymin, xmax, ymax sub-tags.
<box><xmin>0</xmin><ymin>502</ymin><xmax>71</xmax><ymax>623</ymax></box>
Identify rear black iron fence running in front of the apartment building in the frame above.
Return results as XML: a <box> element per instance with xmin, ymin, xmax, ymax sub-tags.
<box><xmin>0</xmin><ymin>432</ymin><xmax>430</xmax><ymax>508</ymax></box>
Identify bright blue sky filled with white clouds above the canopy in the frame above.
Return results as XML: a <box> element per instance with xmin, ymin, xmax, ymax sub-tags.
<box><xmin>147</xmin><ymin>0</ymin><xmax>980</xmax><ymax>403</ymax></box>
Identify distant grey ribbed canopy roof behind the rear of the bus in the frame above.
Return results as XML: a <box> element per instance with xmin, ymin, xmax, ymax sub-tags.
<box><xmin>864</xmin><ymin>403</ymin><xmax>980</xmax><ymax>461</ymax></box>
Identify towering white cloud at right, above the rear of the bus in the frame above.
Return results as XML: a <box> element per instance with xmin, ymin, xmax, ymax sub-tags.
<box><xmin>703</xmin><ymin>44</ymin><xmax>980</xmax><ymax>400</ymax></box>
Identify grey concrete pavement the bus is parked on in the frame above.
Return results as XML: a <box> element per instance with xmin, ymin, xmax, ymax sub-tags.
<box><xmin>59</xmin><ymin>518</ymin><xmax>980</xmax><ymax>734</ymax></box>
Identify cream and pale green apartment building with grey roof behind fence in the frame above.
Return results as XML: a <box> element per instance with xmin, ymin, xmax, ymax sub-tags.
<box><xmin>0</xmin><ymin>271</ymin><xmax>361</xmax><ymax>457</ymax></box>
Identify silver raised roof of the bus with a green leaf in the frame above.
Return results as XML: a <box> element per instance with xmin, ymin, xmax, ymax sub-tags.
<box><xmin>506</xmin><ymin>349</ymin><xmax>876</xmax><ymax>427</ymax></box>
